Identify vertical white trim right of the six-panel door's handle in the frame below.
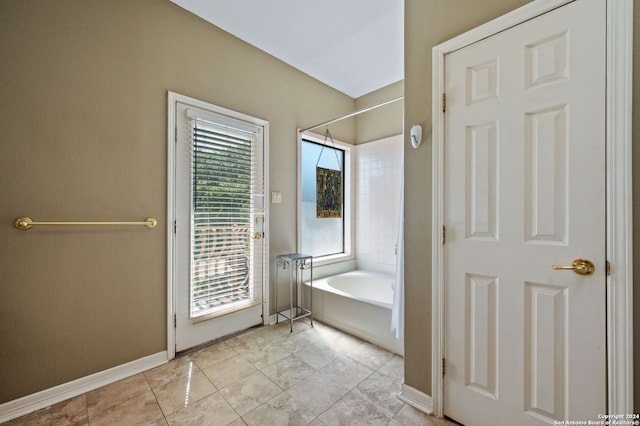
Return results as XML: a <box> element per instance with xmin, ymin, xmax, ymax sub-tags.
<box><xmin>607</xmin><ymin>0</ymin><xmax>634</xmax><ymax>413</ymax></box>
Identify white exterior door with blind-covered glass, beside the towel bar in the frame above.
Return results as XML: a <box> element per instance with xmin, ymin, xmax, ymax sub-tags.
<box><xmin>170</xmin><ymin>94</ymin><xmax>267</xmax><ymax>351</ymax></box>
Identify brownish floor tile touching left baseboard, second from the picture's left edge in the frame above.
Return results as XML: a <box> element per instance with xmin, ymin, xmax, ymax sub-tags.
<box><xmin>87</xmin><ymin>374</ymin><xmax>151</xmax><ymax>417</ymax></box>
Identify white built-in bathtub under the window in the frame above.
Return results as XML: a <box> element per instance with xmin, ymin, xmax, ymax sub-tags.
<box><xmin>305</xmin><ymin>270</ymin><xmax>404</xmax><ymax>355</ymax></box>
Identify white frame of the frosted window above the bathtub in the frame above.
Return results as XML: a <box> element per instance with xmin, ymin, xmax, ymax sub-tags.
<box><xmin>296</xmin><ymin>130</ymin><xmax>356</xmax><ymax>266</ymax></box>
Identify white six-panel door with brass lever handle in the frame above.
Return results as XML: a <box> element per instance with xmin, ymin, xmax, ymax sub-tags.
<box><xmin>444</xmin><ymin>0</ymin><xmax>606</xmax><ymax>426</ymax></box>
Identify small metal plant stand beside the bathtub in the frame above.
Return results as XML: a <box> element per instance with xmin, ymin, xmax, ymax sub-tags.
<box><xmin>275</xmin><ymin>253</ymin><xmax>313</xmax><ymax>332</ymax></box>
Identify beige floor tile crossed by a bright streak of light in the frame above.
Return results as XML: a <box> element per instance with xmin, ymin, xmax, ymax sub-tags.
<box><xmin>153</xmin><ymin>369</ymin><xmax>217</xmax><ymax>416</ymax></box>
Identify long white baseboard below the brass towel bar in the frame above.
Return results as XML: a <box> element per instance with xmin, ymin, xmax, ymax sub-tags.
<box><xmin>0</xmin><ymin>351</ymin><xmax>168</xmax><ymax>423</ymax></box>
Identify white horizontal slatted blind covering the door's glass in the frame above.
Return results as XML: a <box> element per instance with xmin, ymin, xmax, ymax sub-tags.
<box><xmin>190</xmin><ymin>119</ymin><xmax>264</xmax><ymax>320</ymax></box>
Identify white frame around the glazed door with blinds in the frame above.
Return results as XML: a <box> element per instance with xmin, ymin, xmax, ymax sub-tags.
<box><xmin>166</xmin><ymin>91</ymin><xmax>270</xmax><ymax>360</ymax></box>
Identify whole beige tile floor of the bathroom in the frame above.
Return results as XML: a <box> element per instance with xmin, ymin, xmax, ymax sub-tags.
<box><xmin>5</xmin><ymin>320</ymin><xmax>453</xmax><ymax>426</ymax></box>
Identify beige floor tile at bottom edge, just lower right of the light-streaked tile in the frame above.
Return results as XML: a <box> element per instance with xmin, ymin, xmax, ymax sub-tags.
<box><xmin>167</xmin><ymin>392</ymin><xmax>240</xmax><ymax>426</ymax></box>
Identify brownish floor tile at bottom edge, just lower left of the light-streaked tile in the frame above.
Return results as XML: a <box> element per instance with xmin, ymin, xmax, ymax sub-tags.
<box><xmin>89</xmin><ymin>389</ymin><xmax>164</xmax><ymax>426</ymax></box>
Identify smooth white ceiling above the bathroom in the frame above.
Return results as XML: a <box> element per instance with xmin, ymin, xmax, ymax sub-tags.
<box><xmin>171</xmin><ymin>0</ymin><xmax>404</xmax><ymax>98</ymax></box>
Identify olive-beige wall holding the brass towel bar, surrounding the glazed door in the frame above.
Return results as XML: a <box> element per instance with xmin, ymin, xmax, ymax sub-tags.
<box><xmin>0</xmin><ymin>0</ymin><xmax>355</xmax><ymax>403</ymax></box>
